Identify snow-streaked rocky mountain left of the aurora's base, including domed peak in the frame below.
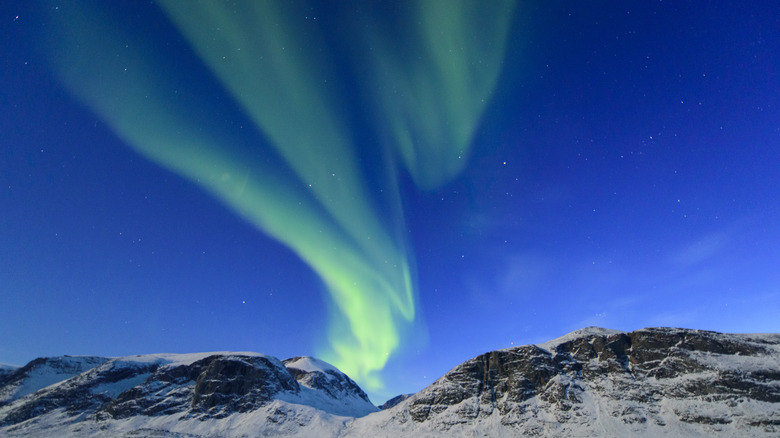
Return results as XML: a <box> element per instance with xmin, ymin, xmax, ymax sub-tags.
<box><xmin>0</xmin><ymin>353</ymin><xmax>376</xmax><ymax>436</ymax></box>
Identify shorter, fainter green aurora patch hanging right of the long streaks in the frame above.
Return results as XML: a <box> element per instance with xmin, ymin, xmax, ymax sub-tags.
<box><xmin>369</xmin><ymin>0</ymin><xmax>514</xmax><ymax>189</ymax></box>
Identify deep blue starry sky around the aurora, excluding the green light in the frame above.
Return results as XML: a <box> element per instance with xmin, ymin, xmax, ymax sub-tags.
<box><xmin>0</xmin><ymin>1</ymin><xmax>780</xmax><ymax>402</ymax></box>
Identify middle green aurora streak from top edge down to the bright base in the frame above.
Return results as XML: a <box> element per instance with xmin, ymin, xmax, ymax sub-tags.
<box><xmin>155</xmin><ymin>0</ymin><xmax>414</xmax><ymax>381</ymax></box>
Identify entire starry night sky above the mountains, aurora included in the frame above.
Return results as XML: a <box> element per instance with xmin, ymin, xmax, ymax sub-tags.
<box><xmin>0</xmin><ymin>0</ymin><xmax>780</xmax><ymax>403</ymax></box>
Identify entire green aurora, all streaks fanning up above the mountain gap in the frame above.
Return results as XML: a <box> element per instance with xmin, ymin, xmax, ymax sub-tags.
<box><xmin>48</xmin><ymin>0</ymin><xmax>512</xmax><ymax>390</ymax></box>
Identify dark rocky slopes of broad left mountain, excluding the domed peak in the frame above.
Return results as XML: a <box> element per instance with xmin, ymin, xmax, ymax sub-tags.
<box><xmin>0</xmin><ymin>354</ymin><xmax>299</xmax><ymax>425</ymax></box>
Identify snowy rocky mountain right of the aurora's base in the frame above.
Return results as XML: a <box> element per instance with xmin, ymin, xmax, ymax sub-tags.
<box><xmin>348</xmin><ymin>329</ymin><xmax>780</xmax><ymax>436</ymax></box>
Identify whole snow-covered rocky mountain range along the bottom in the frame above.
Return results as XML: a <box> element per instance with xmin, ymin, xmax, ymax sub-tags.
<box><xmin>0</xmin><ymin>328</ymin><xmax>780</xmax><ymax>437</ymax></box>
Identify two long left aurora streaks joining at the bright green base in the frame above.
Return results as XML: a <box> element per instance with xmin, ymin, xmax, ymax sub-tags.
<box><xmin>44</xmin><ymin>2</ymin><xmax>415</xmax><ymax>389</ymax></box>
